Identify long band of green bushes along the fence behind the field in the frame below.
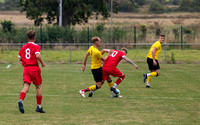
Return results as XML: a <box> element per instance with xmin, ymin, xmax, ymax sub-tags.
<box><xmin>0</xmin><ymin>22</ymin><xmax>200</xmax><ymax>47</ymax></box>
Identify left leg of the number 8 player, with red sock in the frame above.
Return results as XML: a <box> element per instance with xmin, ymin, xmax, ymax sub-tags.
<box><xmin>18</xmin><ymin>82</ymin><xmax>30</xmax><ymax>113</ymax></box>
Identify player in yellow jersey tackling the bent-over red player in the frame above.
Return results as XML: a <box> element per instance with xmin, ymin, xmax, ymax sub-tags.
<box><xmin>79</xmin><ymin>37</ymin><xmax>113</xmax><ymax>97</ymax></box>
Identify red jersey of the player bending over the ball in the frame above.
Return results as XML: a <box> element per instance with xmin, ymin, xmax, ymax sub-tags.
<box><xmin>103</xmin><ymin>50</ymin><xmax>126</xmax><ymax>67</ymax></box>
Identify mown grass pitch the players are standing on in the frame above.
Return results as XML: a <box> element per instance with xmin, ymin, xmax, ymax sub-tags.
<box><xmin>0</xmin><ymin>63</ymin><xmax>200</xmax><ymax>125</ymax></box>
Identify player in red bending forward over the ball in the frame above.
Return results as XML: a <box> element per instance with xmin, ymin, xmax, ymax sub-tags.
<box><xmin>102</xmin><ymin>48</ymin><xmax>138</xmax><ymax>94</ymax></box>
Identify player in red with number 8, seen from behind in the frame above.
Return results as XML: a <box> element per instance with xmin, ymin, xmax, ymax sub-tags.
<box><xmin>18</xmin><ymin>30</ymin><xmax>45</xmax><ymax>113</ymax></box>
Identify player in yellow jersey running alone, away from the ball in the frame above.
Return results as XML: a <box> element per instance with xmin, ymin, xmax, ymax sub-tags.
<box><xmin>143</xmin><ymin>34</ymin><xmax>165</xmax><ymax>88</ymax></box>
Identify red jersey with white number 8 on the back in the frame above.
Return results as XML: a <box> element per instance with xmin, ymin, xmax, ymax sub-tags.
<box><xmin>18</xmin><ymin>42</ymin><xmax>40</xmax><ymax>67</ymax></box>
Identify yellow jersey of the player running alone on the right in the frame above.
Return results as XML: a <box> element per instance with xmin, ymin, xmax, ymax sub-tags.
<box><xmin>147</xmin><ymin>41</ymin><xmax>162</xmax><ymax>60</ymax></box>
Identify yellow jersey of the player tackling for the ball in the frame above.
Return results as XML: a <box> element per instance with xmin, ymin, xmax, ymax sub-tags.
<box><xmin>88</xmin><ymin>46</ymin><xmax>102</xmax><ymax>69</ymax></box>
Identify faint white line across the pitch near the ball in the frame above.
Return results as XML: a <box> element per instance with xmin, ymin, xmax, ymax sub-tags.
<box><xmin>0</xmin><ymin>93</ymin><xmax>200</xmax><ymax>100</ymax></box>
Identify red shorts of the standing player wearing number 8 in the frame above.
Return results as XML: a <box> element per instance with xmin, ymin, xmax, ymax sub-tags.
<box><xmin>23</xmin><ymin>66</ymin><xmax>42</xmax><ymax>85</ymax></box>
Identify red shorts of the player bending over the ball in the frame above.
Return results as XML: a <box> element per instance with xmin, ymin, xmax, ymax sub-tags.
<box><xmin>102</xmin><ymin>67</ymin><xmax>123</xmax><ymax>81</ymax></box>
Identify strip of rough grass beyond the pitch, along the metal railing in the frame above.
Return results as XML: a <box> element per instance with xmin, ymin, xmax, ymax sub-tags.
<box><xmin>0</xmin><ymin>48</ymin><xmax>200</xmax><ymax>64</ymax></box>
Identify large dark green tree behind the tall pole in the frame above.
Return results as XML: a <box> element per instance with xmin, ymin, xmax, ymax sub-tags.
<box><xmin>19</xmin><ymin>0</ymin><xmax>118</xmax><ymax>26</ymax></box>
